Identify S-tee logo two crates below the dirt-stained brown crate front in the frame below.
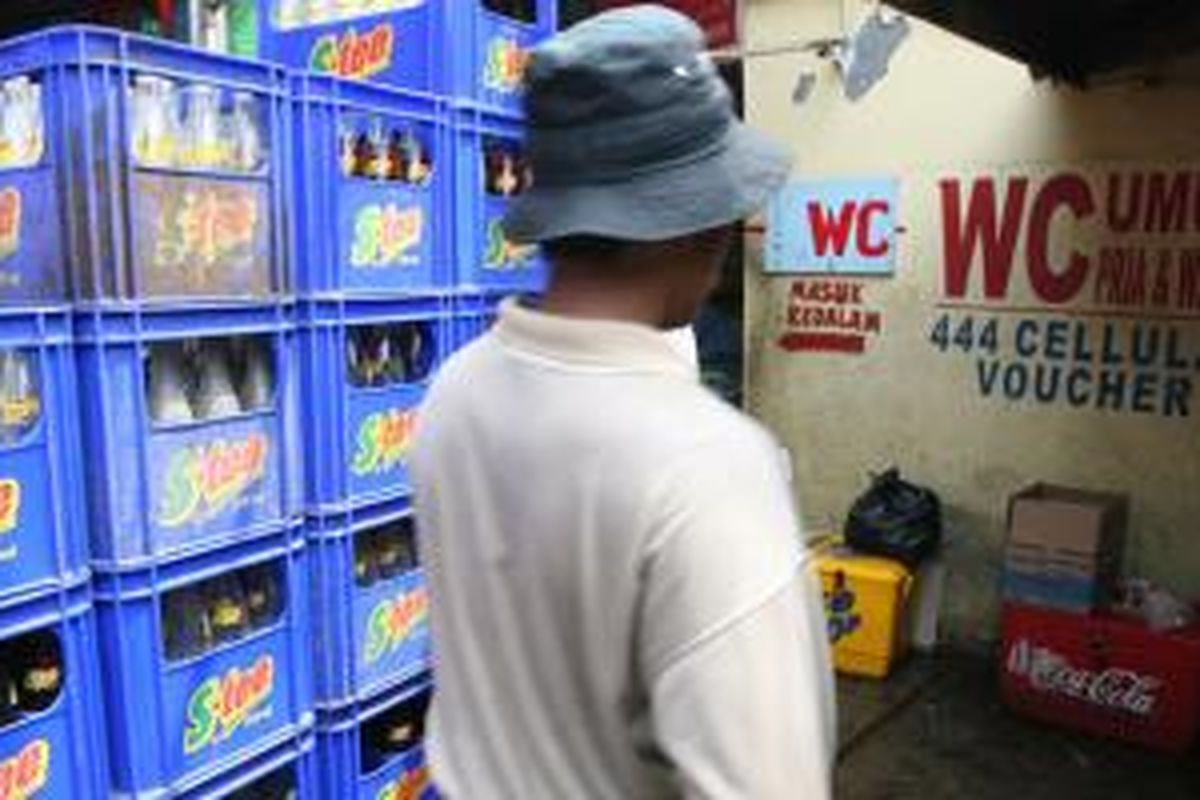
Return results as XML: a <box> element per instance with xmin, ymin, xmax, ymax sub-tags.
<box><xmin>184</xmin><ymin>655</ymin><xmax>275</xmax><ymax>756</ymax></box>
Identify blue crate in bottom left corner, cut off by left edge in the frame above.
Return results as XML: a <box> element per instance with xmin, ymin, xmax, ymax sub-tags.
<box><xmin>0</xmin><ymin>582</ymin><xmax>109</xmax><ymax>800</ymax></box>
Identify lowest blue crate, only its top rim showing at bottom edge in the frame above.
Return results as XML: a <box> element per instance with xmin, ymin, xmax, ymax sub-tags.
<box><xmin>179</xmin><ymin>728</ymin><xmax>322</xmax><ymax>800</ymax></box>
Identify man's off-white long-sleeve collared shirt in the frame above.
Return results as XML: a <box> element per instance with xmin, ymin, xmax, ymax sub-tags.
<box><xmin>413</xmin><ymin>297</ymin><xmax>834</xmax><ymax>800</ymax></box>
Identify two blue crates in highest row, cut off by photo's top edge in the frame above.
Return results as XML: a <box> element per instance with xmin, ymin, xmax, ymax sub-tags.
<box><xmin>260</xmin><ymin>0</ymin><xmax>558</xmax><ymax>112</ymax></box>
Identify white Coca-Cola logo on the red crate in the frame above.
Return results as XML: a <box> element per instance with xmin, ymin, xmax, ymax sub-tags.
<box><xmin>1006</xmin><ymin>639</ymin><xmax>1163</xmax><ymax>717</ymax></box>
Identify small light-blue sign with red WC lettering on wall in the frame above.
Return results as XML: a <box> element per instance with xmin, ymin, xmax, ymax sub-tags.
<box><xmin>766</xmin><ymin>178</ymin><xmax>899</xmax><ymax>275</ymax></box>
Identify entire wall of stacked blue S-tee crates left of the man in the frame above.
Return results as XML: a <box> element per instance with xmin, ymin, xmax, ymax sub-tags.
<box><xmin>0</xmin><ymin>0</ymin><xmax>556</xmax><ymax>800</ymax></box>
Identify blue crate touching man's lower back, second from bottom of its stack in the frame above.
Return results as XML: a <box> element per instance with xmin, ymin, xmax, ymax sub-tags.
<box><xmin>308</xmin><ymin>501</ymin><xmax>431</xmax><ymax>705</ymax></box>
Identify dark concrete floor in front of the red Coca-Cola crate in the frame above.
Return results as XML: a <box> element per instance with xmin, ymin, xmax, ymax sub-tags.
<box><xmin>836</xmin><ymin>656</ymin><xmax>1200</xmax><ymax>800</ymax></box>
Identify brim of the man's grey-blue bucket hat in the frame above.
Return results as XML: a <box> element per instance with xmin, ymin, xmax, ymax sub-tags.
<box><xmin>504</xmin><ymin>122</ymin><xmax>792</xmax><ymax>245</ymax></box>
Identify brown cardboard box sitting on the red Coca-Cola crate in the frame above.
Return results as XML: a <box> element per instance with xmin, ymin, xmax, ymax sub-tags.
<box><xmin>1004</xmin><ymin>483</ymin><xmax>1129</xmax><ymax>612</ymax></box>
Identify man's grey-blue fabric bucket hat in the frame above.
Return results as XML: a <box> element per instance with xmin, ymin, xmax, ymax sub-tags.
<box><xmin>504</xmin><ymin>6</ymin><xmax>791</xmax><ymax>243</ymax></box>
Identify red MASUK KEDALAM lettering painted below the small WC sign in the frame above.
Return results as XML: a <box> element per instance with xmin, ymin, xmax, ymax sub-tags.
<box><xmin>779</xmin><ymin>278</ymin><xmax>883</xmax><ymax>354</ymax></box>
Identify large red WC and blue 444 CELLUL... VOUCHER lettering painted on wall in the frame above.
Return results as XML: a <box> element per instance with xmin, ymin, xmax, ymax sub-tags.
<box><xmin>929</xmin><ymin>169</ymin><xmax>1200</xmax><ymax>417</ymax></box>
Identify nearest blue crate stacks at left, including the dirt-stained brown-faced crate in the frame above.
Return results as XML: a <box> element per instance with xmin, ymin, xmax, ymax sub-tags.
<box><xmin>0</xmin><ymin>28</ymin><xmax>316</xmax><ymax>799</ymax></box>
